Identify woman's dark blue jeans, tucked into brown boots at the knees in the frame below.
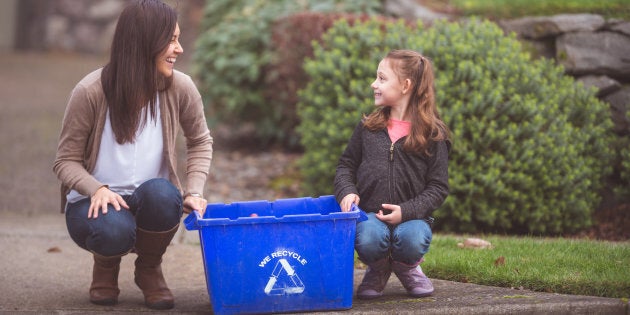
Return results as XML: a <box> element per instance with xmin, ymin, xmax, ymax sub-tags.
<box><xmin>66</xmin><ymin>178</ymin><xmax>183</xmax><ymax>256</ymax></box>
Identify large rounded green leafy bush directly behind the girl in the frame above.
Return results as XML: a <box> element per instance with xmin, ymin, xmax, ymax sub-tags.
<box><xmin>298</xmin><ymin>19</ymin><xmax>612</xmax><ymax>234</ymax></box>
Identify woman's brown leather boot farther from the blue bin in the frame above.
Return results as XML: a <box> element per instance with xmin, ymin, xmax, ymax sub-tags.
<box><xmin>90</xmin><ymin>254</ymin><xmax>122</xmax><ymax>305</ymax></box>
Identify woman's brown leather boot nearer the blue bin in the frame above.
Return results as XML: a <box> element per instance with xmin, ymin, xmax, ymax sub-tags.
<box><xmin>135</xmin><ymin>224</ymin><xmax>179</xmax><ymax>310</ymax></box>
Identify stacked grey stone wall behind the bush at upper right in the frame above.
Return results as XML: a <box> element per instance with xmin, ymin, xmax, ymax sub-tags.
<box><xmin>498</xmin><ymin>14</ymin><xmax>630</xmax><ymax>136</ymax></box>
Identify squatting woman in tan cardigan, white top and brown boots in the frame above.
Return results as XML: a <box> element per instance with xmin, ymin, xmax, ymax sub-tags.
<box><xmin>53</xmin><ymin>0</ymin><xmax>212</xmax><ymax>309</ymax></box>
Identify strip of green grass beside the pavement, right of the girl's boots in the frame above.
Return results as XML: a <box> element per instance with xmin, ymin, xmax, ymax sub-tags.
<box><xmin>422</xmin><ymin>234</ymin><xmax>630</xmax><ymax>298</ymax></box>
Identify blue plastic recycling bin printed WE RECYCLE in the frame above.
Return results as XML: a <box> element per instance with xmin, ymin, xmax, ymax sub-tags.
<box><xmin>184</xmin><ymin>196</ymin><xmax>364</xmax><ymax>314</ymax></box>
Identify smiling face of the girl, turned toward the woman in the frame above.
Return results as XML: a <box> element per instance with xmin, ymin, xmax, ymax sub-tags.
<box><xmin>371</xmin><ymin>59</ymin><xmax>406</xmax><ymax>107</ymax></box>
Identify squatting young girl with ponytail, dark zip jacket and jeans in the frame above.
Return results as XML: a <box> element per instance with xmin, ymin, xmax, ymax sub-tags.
<box><xmin>335</xmin><ymin>50</ymin><xmax>450</xmax><ymax>299</ymax></box>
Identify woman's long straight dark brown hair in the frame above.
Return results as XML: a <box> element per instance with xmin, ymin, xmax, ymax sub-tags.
<box><xmin>101</xmin><ymin>0</ymin><xmax>177</xmax><ymax>144</ymax></box>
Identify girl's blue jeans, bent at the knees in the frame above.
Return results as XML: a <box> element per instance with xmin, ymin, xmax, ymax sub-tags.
<box><xmin>354</xmin><ymin>213</ymin><xmax>433</xmax><ymax>265</ymax></box>
